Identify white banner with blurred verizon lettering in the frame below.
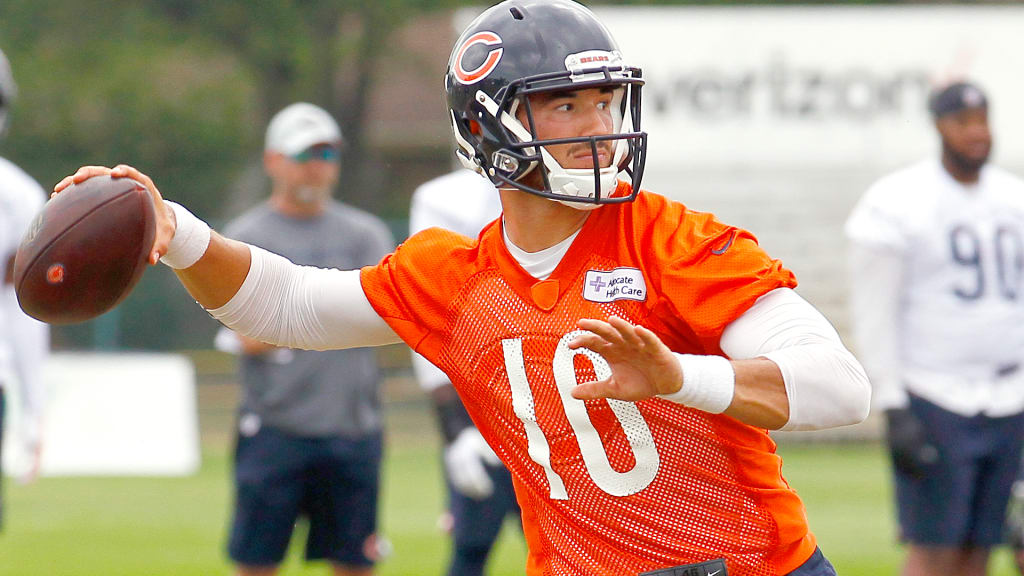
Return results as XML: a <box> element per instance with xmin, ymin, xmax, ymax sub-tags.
<box><xmin>595</xmin><ymin>5</ymin><xmax>1024</xmax><ymax>171</ymax></box>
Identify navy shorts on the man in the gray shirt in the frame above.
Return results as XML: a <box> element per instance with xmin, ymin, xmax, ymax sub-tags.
<box><xmin>228</xmin><ymin>426</ymin><xmax>383</xmax><ymax>566</ymax></box>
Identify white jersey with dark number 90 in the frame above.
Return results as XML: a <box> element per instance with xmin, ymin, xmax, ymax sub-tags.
<box><xmin>846</xmin><ymin>159</ymin><xmax>1024</xmax><ymax>417</ymax></box>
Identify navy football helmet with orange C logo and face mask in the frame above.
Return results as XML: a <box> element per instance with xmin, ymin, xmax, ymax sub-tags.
<box><xmin>444</xmin><ymin>0</ymin><xmax>647</xmax><ymax>208</ymax></box>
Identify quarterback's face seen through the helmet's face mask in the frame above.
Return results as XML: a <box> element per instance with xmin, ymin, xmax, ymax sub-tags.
<box><xmin>516</xmin><ymin>87</ymin><xmax>622</xmax><ymax>169</ymax></box>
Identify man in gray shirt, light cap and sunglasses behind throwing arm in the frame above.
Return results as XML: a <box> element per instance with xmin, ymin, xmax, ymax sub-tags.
<box><xmin>216</xmin><ymin>102</ymin><xmax>394</xmax><ymax>576</ymax></box>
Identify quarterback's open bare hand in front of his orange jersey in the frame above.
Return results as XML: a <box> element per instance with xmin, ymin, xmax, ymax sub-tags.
<box><xmin>568</xmin><ymin>317</ymin><xmax>683</xmax><ymax>402</ymax></box>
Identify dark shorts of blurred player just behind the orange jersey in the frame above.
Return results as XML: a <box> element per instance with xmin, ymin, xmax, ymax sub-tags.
<box><xmin>449</xmin><ymin>457</ymin><xmax>520</xmax><ymax>552</ymax></box>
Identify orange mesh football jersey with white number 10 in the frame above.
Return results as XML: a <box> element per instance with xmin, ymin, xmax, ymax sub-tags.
<box><xmin>361</xmin><ymin>183</ymin><xmax>815</xmax><ymax>576</ymax></box>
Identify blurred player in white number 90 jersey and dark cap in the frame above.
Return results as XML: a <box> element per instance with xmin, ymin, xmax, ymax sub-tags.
<box><xmin>846</xmin><ymin>82</ymin><xmax>1024</xmax><ymax>576</ymax></box>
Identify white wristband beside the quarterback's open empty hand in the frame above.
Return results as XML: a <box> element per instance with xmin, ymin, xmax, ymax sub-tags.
<box><xmin>659</xmin><ymin>354</ymin><xmax>736</xmax><ymax>414</ymax></box>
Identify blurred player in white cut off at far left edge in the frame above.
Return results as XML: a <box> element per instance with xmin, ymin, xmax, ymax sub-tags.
<box><xmin>0</xmin><ymin>45</ymin><xmax>49</xmax><ymax>527</ymax></box>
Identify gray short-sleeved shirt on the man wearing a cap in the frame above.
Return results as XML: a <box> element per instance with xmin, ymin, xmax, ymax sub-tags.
<box><xmin>225</xmin><ymin>200</ymin><xmax>394</xmax><ymax>437</ymax></box>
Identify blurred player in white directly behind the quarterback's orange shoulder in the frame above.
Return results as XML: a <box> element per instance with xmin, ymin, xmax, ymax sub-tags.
<box><xmin>409</xmin><ymin>168</ymin><xmax>519</xmax><ymax>576</ymax></box>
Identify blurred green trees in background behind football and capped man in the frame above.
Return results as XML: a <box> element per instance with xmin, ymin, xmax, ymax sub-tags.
<box><xmin>0</xmin><ymin>0</ymin><xmax>456</xmax><ymax>349</ymax></box>
